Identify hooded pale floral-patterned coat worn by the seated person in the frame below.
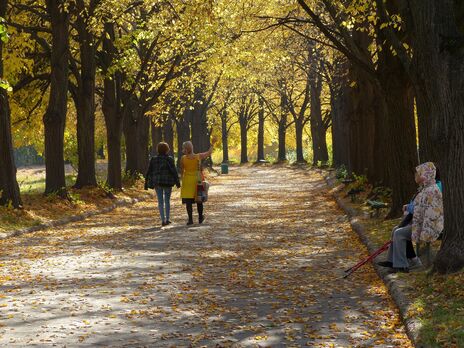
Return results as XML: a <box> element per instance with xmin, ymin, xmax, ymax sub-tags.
<box><xmin>411</xmin><ymin>162</ymin><xmax>444</xmax><ymax>242</ymax></box>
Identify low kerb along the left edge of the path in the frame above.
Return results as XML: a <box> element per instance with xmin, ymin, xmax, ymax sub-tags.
<box><xmin>0</xmin><ymin>197</ymin><xmax>149</xmax><ymax>240</ymax></box>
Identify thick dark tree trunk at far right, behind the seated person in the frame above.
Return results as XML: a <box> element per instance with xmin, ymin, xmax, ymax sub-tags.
<box><xmin>407</xmin><ymin>0</ymin><xmax>464</xmax><ymax>273</ymax></box>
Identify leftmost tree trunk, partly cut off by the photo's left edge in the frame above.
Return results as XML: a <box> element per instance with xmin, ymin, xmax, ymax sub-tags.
<box><xmin>0</xmin><ymin>0</ymin><xmax>21</xmax><ymax>208</ymax></box>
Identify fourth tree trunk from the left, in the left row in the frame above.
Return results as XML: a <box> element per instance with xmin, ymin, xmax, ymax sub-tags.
<box><xmin>102</xmin><ymin>23</ymin><xmax>124</xmax><ymax>191</ymax></box>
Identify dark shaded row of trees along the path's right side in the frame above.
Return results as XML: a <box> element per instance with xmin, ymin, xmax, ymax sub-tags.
<box><xmin>286</xmin><ymin>0</ymin><xmax>464</xmax><ymax>273</ymax></box>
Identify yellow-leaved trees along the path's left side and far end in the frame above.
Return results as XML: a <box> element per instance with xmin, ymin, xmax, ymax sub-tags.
<box><xmin>1</xmin><ymin>0</ymin><xmax>329</xmax><ymax>206</ymax></box>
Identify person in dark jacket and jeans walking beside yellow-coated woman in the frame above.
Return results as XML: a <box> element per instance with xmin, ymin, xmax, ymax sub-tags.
<box><xmin>145</xmin><ymin>143</ymin><xmax>180</xmax><ymax>226</ymax></box>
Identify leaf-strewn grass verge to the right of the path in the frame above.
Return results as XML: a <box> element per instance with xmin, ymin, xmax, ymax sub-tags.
<box><xmin>338</xmin><ymin>178</ymin><xmax>464</xmax><ymax>348</ymax></box>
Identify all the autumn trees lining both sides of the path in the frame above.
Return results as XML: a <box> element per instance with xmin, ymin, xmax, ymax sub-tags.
<box><xmin>0</xmin><ymin>0</ymin><xmax>464</xmax><ymax>273</ymax></box>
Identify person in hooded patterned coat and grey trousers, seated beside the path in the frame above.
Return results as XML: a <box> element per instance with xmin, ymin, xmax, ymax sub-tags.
<box><xmin>378</xmin><ymin>162</ymin><xmax>444</xmax><ymax>272</ymax></box>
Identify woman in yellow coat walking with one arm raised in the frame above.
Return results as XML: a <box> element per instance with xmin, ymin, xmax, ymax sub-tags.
<box><xmin>180</xmin><ymin>141</ymin><xmax>213</xmax><ymax>225</ymax></box>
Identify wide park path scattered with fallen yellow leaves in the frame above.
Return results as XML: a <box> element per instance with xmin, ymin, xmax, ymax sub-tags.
<box><xmin>0</xmin><ymin>167</ymin><xmax>411</xmax><ymax>347</ymax></box>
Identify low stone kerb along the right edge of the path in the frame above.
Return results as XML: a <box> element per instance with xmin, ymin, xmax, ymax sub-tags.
<box><xmin>323</xmin><ymin>173</ymin><xmax>422</xmax><ymax>347</ymax></box>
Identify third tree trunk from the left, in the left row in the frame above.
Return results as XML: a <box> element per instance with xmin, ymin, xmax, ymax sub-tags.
<box><xmin>74</xmin><ymin>12</ymin><xmax>97</xmax><ymax>188</ymax></box>
